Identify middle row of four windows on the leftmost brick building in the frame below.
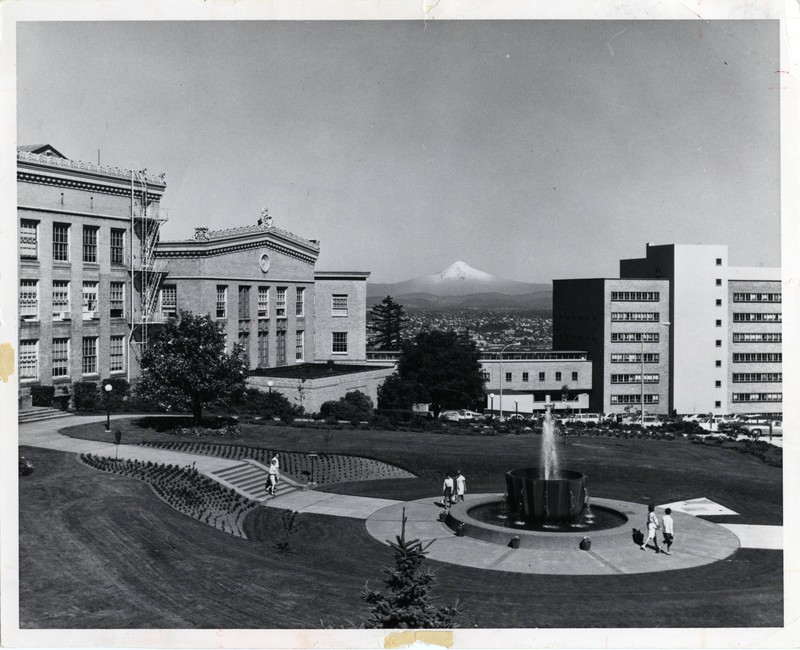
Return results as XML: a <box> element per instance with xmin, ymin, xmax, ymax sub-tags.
<box><xmin>19</xmin><ymin>280</ymin><xmax>125</xmax><ymax>320</ymax></box>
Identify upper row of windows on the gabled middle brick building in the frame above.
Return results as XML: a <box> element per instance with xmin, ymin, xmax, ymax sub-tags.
<box><xmin>159</xmin><ymin>284</ymin><xmax>348</xmax><ymax>320</ymax></box>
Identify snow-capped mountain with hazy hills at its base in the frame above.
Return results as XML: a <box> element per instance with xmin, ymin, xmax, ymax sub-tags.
<box><xmin>367</xmin><ymin>262</ymin><xmax>553</xmax><ymax>310</ymax></box>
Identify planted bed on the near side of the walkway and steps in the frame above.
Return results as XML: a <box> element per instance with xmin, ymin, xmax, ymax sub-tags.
<box><xmin>80</xmin><ymin>454</ymin><xmax>258</xmax><ymax>538</ymax></box>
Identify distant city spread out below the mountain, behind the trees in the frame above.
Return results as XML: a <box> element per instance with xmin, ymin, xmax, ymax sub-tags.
<box><xmin>372</xmin><ymin>308</ymin><xmax>553</xmax><ymax>350</ymax></box>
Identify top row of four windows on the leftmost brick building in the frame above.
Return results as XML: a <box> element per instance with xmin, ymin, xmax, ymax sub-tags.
<box><xmin>19</xmin><ymin>219</ymin><xmax>125</xmax><ymax>264</ymax></box>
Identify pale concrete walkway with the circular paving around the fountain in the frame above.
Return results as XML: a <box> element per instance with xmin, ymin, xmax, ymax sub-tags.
<box><xmin>19</xmin><ymin>414</ymin><xmax>783</xmax><ymax>575</ymax></box>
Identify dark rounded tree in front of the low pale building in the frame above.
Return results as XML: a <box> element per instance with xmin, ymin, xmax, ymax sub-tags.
<box><xmin>378</xmin><ymin>331</ymin><xmax>485</xmax><ymax>417</ymax></box>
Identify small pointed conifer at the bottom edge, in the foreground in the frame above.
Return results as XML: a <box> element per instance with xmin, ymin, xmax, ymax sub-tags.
<box><xmin>361</xmin><ymin>508</ymin><xmax>460</xmax><ymax>629</ymax></box>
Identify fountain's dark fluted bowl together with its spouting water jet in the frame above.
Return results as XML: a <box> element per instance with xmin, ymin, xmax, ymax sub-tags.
<box><xmin>506</xmin><ymin>396</ymin><xmax>588</xmax><ymax>523</ymax></box>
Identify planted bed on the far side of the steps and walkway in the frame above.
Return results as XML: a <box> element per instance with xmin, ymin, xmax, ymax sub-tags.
<box><xmin>135</xmin><ymin>441</ymin><xmax>415</xmax><ymax>484</ymax></box>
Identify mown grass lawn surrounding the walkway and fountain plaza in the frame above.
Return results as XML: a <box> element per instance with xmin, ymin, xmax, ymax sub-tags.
<box><xmin>20</xmin><ymin>422</ymin><xmax>783</xmax><ymax>628</ymax></box>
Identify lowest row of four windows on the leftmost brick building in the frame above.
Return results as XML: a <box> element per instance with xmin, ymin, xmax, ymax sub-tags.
<box><xmin>19</xmin><ymin>336</ymin><xmax>125</xmax><ymax>381</ymax></box>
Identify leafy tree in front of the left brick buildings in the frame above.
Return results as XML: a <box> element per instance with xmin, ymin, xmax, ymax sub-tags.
<box><xmin>139</xmin><ymin>310</ymin><xmax>247</xmax><ymax>422</ymax></box>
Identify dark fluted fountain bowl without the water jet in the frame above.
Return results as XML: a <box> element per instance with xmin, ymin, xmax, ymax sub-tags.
<box><xmin>506</xmin><ymin>467</ymin><xmax>587</xmax><ymax>523</ymax></box>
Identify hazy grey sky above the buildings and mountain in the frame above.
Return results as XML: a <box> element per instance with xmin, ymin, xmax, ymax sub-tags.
<box><xmin>18</xmin><ymin>20</ymin><xmax>780</xmax><ymax>282</ymax></box>
